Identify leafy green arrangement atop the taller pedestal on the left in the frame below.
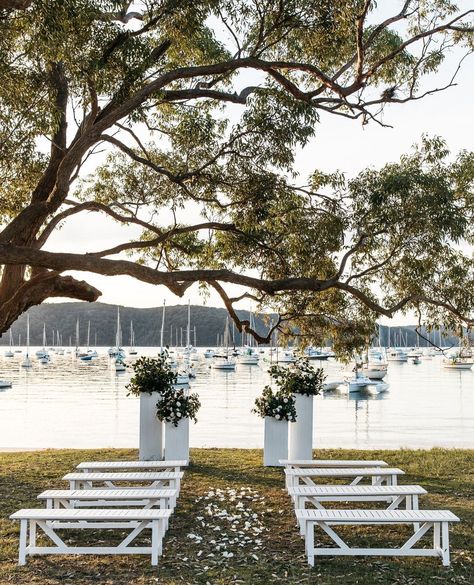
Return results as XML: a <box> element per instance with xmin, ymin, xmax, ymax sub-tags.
<box><xmin>126</xmin><ymin>350</ymin><xmax>177</xmax><ymax>396</ymax></box>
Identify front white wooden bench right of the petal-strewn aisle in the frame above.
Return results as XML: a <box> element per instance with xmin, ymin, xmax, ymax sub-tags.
<box><xmin>296</xmin><ymin>510</ymin><xmax>459</xmax><ymax>567</ymax></box>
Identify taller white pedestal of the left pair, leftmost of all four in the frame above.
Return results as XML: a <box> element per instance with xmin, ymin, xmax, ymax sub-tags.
<box><xmin>139</xmin><ymin>392</ymin><xmax>163</xmax><ymax>461</ymax></box>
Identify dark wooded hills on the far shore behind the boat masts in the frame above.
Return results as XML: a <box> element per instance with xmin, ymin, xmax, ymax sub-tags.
<box><xmin>0</xmin><ymin>303</ymin><xmax>466</xmax><ymax>347</ymax></box>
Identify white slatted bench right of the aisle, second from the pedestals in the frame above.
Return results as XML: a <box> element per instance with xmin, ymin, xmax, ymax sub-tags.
<box><xmin>285</xmin><ymin>467</ymin><xmax>405</xmax><ymax>489</ymax></box>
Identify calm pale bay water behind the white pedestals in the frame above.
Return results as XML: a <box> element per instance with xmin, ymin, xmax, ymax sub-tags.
<box><xmin>0</xmin><ymin>348</ymin><xmax>474</xmax><ymax>449</ymax></box>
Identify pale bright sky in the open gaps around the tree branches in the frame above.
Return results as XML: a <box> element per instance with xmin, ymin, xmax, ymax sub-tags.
<box><xmin>45</xmin><ymin>4</ymin><xmax>474</xmax><ymax>324</ymax></box>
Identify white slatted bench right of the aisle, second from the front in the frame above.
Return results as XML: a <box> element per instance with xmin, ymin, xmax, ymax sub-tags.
<box><xmin>288</xmin><ymin>485</ymin><xmax>427</xmax><ymax>535</ymax></box>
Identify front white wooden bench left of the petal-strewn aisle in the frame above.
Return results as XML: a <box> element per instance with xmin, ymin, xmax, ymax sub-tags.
<box><xmin>10</xmin><ymin>508</ymin><xmax>172</xmax><ymax>565</ymax></box>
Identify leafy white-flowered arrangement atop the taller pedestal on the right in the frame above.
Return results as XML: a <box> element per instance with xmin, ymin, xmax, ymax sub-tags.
<box><xmin>268</xmin><ymin>357</ymin><xmax>326</xmax><ymax>396</ymax></box>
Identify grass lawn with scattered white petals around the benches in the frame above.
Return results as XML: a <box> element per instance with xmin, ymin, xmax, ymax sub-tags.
<box><xmin>0</xmin><ymin>449</ymin><xmax>474</xmax><ymax>585</ymax></box>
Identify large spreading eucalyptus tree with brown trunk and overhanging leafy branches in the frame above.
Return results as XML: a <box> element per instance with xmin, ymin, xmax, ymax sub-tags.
<box><xmin>0</xmin><ymin>0</ymin><xmax>474</xmax><ymax>347</ymax></box>
